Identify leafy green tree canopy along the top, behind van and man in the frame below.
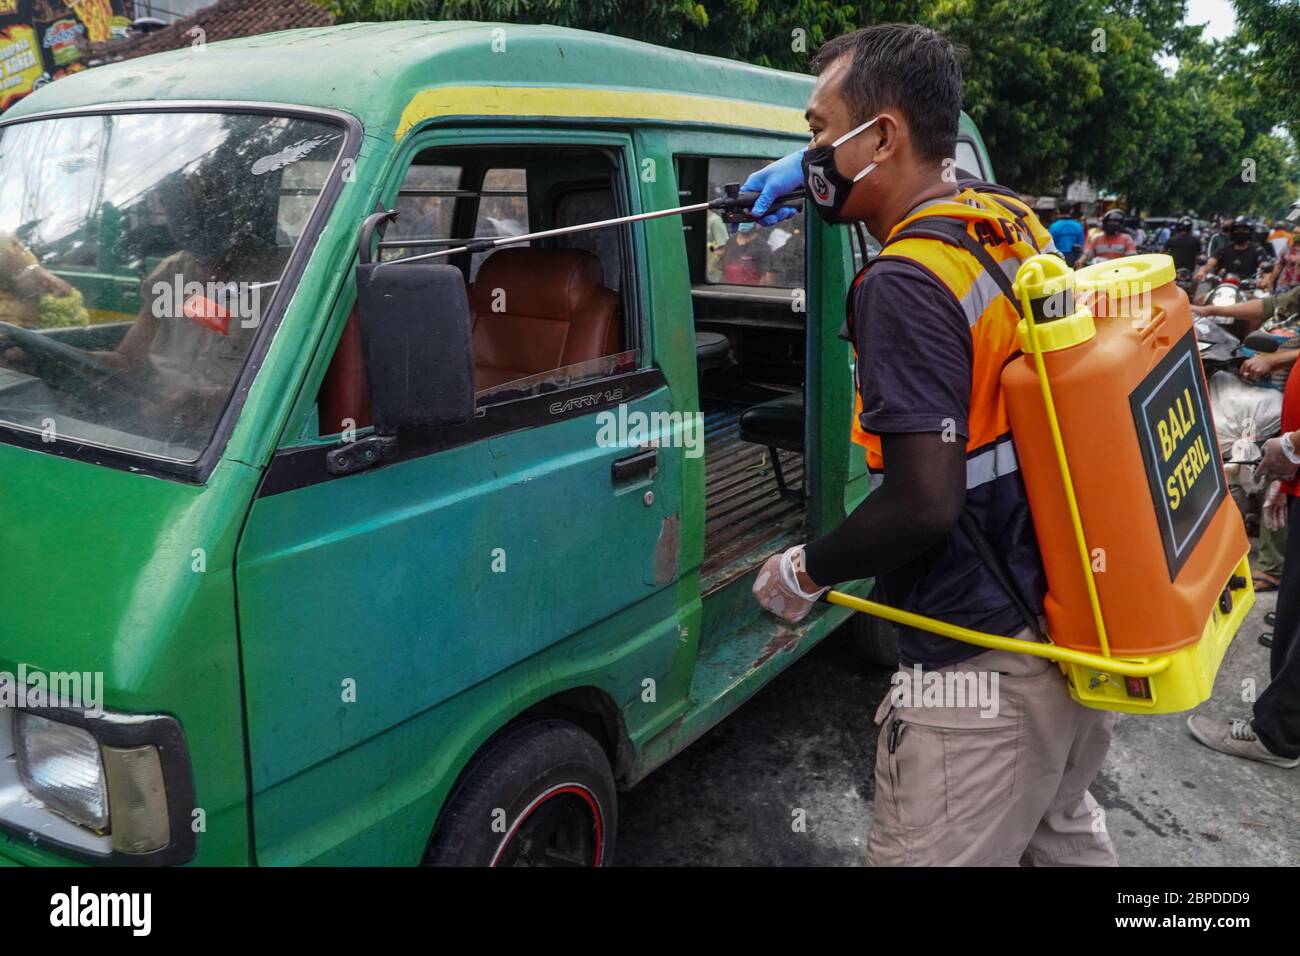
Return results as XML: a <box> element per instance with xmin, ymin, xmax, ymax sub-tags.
<box><xmin>317</xmin><ymin>0</ymin><xmax>1300</xmax><ymax>212</ymax></box>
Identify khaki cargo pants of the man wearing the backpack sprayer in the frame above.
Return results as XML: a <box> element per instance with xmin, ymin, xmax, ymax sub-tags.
<box><xmin>867</xmin><ymin>631</ymin><xmax>1117</xmax><ymax>866</ymax></box>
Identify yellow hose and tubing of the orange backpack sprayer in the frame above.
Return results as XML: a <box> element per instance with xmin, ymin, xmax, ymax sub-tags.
<box><xmin>826</xmin><ymin>259</ymin><xmax>1171</xmax><ymax>678</ymax></box>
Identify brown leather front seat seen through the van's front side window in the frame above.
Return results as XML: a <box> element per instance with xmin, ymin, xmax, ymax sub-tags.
<box><xmin>469</xmin><ymin>248</ymin><xmax>621</xmax><ymax>390</ymax></box>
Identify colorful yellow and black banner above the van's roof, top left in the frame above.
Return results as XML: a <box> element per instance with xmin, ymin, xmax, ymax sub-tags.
<box><xmin>0</xmin><ymin>0</ymin><xmax>131</xmax><ymax>112</ymax></box>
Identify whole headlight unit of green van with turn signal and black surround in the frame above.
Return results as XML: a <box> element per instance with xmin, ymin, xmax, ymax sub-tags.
<box><xmin>0</xmin><ymin>708</ymin><xmax>196</xmax><ymax>864</ymax></box>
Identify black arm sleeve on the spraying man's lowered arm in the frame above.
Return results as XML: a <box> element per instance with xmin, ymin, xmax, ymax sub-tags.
<box><xmin>803</xmin><ymin>432</ymin><xmax>966</xmax><ymax>587</ymax></box>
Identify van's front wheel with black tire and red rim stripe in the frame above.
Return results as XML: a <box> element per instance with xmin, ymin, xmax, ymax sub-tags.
<box><xmin>424</xmin><ymin>718</ymin><xmax>618</xmax><ymax>866</ymax></box>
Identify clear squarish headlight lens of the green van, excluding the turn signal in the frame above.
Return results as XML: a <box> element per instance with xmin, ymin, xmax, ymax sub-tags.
<box><xmin>14</xmin><ymin>710</ymin><xmax>108</xmax><ymax>830</ymax></box>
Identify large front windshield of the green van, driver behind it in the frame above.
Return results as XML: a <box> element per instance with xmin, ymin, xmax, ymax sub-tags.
<box><xmin>0</xmin><ymin>112</ymin><xmax>345</xmax><ymax>462</ymax></box>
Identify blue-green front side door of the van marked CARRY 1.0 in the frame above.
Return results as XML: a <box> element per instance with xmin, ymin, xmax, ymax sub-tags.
<box><xmin>238</xmin><ymin>129</ymin><xmax>684</xmax><ymax>864</ymax></box>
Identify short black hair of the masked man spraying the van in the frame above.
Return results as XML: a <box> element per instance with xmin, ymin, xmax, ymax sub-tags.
<box><xmin>810</xmin><ymin>23</ymin><xmax>962</xmax><ymax>163</ymax></box>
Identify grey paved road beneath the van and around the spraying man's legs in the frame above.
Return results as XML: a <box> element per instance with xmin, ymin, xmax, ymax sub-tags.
<box><xmin>616</xmin><ymin>582</ymin><xmax>1300</xmax><ymax>866</ymax></box>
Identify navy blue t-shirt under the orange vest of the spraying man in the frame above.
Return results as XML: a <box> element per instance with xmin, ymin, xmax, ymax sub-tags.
<box><xmin>853</xmin><ymin>259</ymin><xmax>1045</xmax><ymax>667</ymax></box>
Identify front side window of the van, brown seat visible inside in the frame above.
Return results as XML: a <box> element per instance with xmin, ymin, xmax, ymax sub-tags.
<box><xmin>317</xmin><ymin>144</ymin><xmax>641</xmax><ymax>436</ymax></box>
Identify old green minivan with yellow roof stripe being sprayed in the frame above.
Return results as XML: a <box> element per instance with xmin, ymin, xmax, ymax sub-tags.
<box><xmin>0</xmin><ymin>22</ymin><xmax>992</xmax><ymax>865</ymax></box>
